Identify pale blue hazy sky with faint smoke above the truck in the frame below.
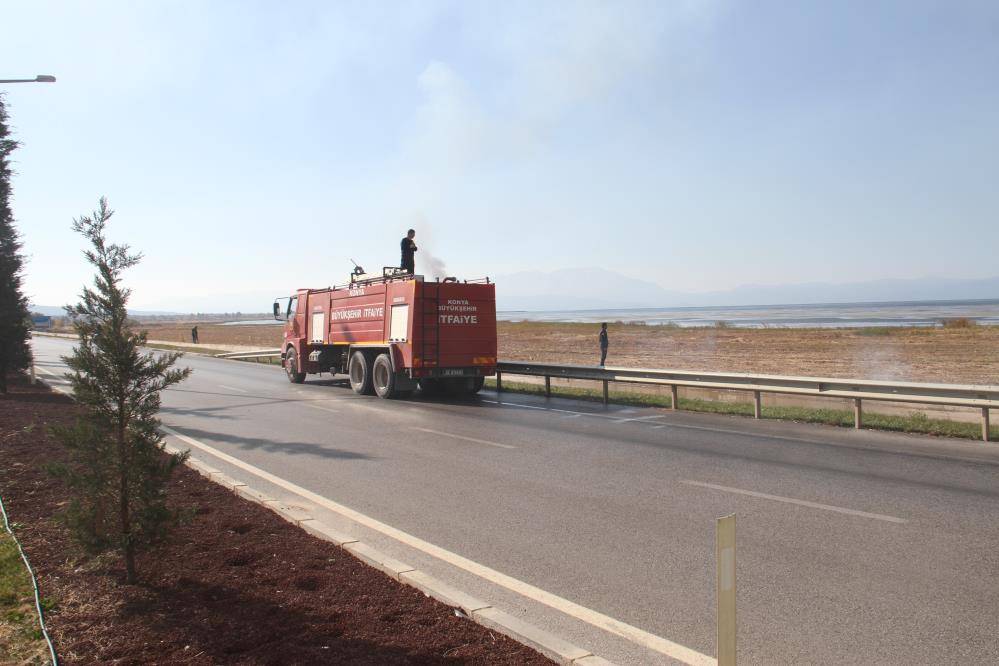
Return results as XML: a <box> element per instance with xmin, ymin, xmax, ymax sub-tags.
<box><xmin>0</xmin><ymin>0</ymin><xmax>999</xmax><ymax>311</ymax></box>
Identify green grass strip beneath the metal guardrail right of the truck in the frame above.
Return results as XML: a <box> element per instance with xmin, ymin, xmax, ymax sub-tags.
<box><xmin>486</xmin><ymin>379</ymin><xmax>999</xmax><ymax>441</ymax></box>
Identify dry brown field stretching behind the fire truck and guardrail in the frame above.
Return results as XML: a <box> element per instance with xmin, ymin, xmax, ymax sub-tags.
<box><xmin>125</xmin><ymin>322</ymin><xmax>999</xmax><ymax>384</ymax></box>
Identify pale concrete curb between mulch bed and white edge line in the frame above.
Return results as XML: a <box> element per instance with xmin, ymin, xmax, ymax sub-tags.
<box><xmin>165</xmin><ymin>444</ymin><xmax>613</xmax><ymax>666</ymax></box>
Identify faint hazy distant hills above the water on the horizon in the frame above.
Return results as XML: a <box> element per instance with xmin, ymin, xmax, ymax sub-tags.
<box><xmin>496</xmin><ymin>268</ymin><xmax>999</xmax><ymax>311</ymax></box>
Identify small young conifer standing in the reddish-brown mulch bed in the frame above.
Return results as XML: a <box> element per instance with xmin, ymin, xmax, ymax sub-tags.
<box><xmin>54</xmin><ymin>198</ymin><xmax>191</xmax><ymax>583</ymax></box>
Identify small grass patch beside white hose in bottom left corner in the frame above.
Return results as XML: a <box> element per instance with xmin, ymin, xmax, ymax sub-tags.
<box><xmin>0</xmin><ymin>523</ymin><xmax>48</xmax><ymax>664</ymax></box>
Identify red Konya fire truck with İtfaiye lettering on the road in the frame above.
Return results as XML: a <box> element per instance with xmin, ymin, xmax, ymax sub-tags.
<box><xmin>274</xmin><ymin>268</ymin><xmax>496</xmax><ymax>398</ymax></box>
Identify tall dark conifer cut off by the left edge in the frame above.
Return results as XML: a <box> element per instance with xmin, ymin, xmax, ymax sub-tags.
<box><xmin>0</xmin><ymin>95</ymin><xmax>31</xmax><ymax>393</ymax></box>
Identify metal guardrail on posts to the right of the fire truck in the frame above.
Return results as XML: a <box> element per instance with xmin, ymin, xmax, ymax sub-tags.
<box><xmin>496</xmin><ymin>361</ymin><xmax>999</xmax><ymax>442</ymax></box>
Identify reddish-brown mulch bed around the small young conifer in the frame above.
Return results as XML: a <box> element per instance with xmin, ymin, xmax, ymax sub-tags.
<box><xmin>0</xmin><ymin>374</ymin><xmax>551</xmax><ymax>665</ymax></box>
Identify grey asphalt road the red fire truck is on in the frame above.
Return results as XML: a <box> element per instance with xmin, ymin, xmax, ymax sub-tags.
<box><xmin>34</xmin><ymin>338</ymin><xmax>999</xmax><ymax>664</ymax></box>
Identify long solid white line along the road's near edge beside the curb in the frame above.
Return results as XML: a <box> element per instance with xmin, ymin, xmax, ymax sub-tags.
<box><xmin>160</xmin><ymin>426</ymin><xmax>718</xmax><ymax>666</ymax></box>
